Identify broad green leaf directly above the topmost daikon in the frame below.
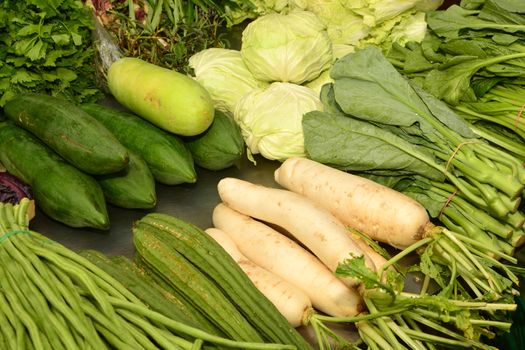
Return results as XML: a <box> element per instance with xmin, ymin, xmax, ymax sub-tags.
<box><xmin>302</xmin><ymin>111</ymin><xmax>444</xmax><ymax>180</ymax></box>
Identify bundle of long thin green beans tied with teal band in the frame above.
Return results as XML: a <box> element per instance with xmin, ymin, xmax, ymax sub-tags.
<box><xmin>0</xmin><ymin>198</ymin><xmax>295</xmax><ymax>350</ymax></box>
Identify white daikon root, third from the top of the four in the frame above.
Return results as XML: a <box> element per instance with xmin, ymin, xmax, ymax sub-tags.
<box><xmin>213</xmin><ymin>203</ymin><xmax>363</xmax><ymax>317</ymax></box>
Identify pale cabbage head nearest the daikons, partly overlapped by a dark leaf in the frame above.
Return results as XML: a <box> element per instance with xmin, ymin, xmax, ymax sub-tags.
<box><xmin>234</xmin><ymin>82</ymin><xmax>323</xmax><ymax>160</ymax></box>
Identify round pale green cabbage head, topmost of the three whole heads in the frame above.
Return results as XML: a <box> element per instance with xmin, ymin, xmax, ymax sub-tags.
<box><xmin>241</xmin><ymin>10</ymin><xmax>332</xmax><ymax>84</ymax></box>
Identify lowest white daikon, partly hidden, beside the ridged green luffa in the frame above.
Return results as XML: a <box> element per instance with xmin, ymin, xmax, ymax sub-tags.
<box><xmin>205</xmin><ymin>228</ymin><xmax>314</xmax><ymax>327</ymax></box>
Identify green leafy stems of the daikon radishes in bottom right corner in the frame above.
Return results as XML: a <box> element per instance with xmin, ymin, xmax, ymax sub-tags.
<box><xmin>326</xmin><ymin>227</ymin><xmax>517</xmax><ymax>349</ymax></box>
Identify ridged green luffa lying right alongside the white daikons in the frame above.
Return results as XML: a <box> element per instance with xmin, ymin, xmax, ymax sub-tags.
<box><xmin>133</xmin><ymin>213</ymin><xmax>312</xmax><ymax>350</ymax></box>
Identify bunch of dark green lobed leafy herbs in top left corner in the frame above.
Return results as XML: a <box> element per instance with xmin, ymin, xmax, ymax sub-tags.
<box><xmin>0</xmin><ymin>0</ymin><xmax>101</xmax><ymax>107</ymax></box>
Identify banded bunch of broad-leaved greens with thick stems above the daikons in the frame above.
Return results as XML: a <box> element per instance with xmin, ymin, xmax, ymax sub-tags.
<box><xmin>303</xmin><ymin>47</ymin><xmax>525</xmax><ymax>251</ymax></box>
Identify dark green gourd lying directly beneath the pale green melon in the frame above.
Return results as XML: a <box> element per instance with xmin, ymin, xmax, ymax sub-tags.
<box><xmin>81</xmin><ymin>103</ymin><xmax>197</xmax><ymax>185</ymax></box>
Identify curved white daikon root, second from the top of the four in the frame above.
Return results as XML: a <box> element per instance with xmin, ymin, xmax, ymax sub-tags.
<box><xmin>217</xmin><ymin>177</ymin><xmax>375</xmax><ymax>285</ymax></box>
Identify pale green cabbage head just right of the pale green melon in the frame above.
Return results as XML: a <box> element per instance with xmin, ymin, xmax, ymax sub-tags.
<box><xmin>189</xmin><ymin>48</ymin><xmax>268</xmax><ymax>114</ymax></box>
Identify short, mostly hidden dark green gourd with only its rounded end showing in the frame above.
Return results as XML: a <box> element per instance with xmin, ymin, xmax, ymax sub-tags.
<box><xmin>97</xmin><ymin>151</ymin><xmax>157</xmax><ymax>209</ymax></box>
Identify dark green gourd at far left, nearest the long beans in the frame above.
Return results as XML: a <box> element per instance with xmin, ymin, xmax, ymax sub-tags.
<box><xmin>0</xmin><ymin>122</ymin><xmax>109</xmax><ymax>229</ymax></box>
